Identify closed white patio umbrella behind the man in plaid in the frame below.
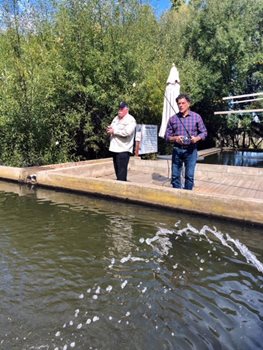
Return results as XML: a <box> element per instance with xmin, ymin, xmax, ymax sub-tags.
<box><xmin>159</xmin><ymin>63</ymin><xmax>180</xmax><ymax>138</ymax></box>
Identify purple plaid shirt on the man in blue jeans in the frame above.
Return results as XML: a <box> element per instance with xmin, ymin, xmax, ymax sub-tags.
<box><xmin>165</xmin><ymin>111</ymin><xmax>207</xmax><ymax>143</ymax></box>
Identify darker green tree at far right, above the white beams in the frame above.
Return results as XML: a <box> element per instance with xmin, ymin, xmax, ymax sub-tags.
<box><xmin>187</xmin><ymin>0</ymin><xmax>263</xmax><ymax>146</ymax></box>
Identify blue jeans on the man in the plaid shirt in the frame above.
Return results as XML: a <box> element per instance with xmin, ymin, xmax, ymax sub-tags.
<box><xmin>171</xmin><ymin>146</ymin><xmax>197</xmax><ymax>190</ymax></box>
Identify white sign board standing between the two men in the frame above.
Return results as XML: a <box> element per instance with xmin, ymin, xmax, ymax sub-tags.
<box><xmin>135</xmin><ymin>124</ymin><xmax>158</xmax><ymax>156</ymax></box>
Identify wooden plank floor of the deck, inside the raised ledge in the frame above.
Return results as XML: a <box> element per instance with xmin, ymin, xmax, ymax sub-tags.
<box><xmin>127</xmin><ymin>148</ymin><xmax>263</xmax><ymax>200</ymax></box>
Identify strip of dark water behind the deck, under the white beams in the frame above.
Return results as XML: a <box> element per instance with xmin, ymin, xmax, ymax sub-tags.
<box><xmin>198</xmin><ymin>151</ymin><xmax>263</xmax><ymax>168</ymax></box>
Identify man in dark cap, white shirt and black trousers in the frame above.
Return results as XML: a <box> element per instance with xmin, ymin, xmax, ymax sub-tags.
<box><xmin>107</xmin><ymin>102</ymin><xmax>136</xmax><ymax>181</ymax></box>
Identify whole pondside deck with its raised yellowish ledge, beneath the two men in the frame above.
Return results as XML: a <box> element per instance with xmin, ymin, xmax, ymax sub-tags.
<box><xmin>0</xmin><ymin>150</ymin><xmax>263</xmax><ymax>225</ymax></box>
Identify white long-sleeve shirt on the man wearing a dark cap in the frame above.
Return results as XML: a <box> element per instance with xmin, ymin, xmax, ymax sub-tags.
<box><xmin>109</xmin><ymin>113</ymin><xmax>136</xmax><ymax>153</ymax></box>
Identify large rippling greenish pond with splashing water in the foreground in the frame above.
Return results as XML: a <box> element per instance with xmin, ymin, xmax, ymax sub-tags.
<box><xmin>0</xmin><ymin>183</ymin><xmax>263</xmax><ymax>350</ymax></box>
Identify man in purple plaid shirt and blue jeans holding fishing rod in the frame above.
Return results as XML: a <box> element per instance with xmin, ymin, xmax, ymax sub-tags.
<box><xmin>165</xmin><ymin>94</ymin><xmax>207</xmax><ymax>190</ymax></box>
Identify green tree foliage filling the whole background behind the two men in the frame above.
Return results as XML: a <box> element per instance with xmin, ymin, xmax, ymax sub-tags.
<box><xmin>0</xmin><ymin>0</ymin><xmax>263</xmax><ymax>166</ymax></box>
